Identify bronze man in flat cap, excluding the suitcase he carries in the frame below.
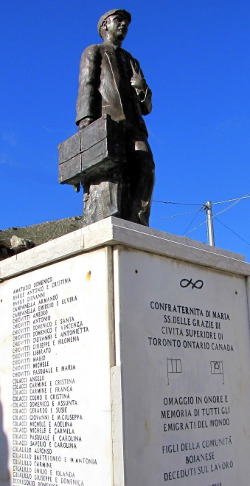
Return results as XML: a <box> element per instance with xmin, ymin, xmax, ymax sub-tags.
<box><xmin>76</xmin><ymin>9</ymin><xmax>154</xmax><ymax>226</ymax></box>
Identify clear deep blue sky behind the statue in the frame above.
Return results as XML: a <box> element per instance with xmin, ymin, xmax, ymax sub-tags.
<box><xmin>0</xmin><ymin>0</ymin><xmax>250</xmax><ymax>261</ymax></box>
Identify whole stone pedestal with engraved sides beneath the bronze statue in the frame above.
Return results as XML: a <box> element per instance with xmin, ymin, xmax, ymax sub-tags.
<box><xmin>0</xmin><ymin>218</ymin><xmax>250</xmax><ymax>486</ymax></box>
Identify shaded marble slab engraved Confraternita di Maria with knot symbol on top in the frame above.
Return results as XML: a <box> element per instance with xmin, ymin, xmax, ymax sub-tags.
<box><xmin>115</xmin><ymin>249</ymin><xmax>250</xmax><ymax>486</ymax></box>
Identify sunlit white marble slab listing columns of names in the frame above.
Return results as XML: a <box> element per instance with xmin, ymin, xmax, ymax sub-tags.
<box><xmin>0</xmin><ymin>248</ymin><xmax>113</xmax><ymax>486</ymax></box>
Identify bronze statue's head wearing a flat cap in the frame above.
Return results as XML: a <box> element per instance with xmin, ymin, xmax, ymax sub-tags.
<box><xmin>97</xmin><ymin>9</ymin><xmax>131</xmax><ymax>42</ymax></box>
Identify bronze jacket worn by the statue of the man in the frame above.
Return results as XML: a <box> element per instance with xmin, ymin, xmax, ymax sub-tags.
<box><xmin>76</xmin><ymin>42</ymin><xmax>152</xmax><ymax>134</ymax></box>
